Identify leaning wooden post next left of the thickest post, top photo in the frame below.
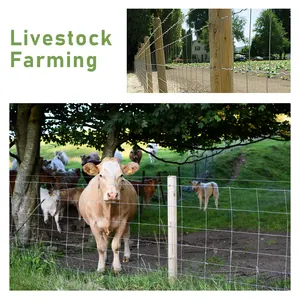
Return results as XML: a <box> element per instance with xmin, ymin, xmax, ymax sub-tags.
<box><xmin>153</xmin><ymin>18</ymin><xmax>168</xmax><ymax>93</ymax></box>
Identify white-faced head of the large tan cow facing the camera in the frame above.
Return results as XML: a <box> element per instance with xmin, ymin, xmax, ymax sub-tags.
<box><xmin>83</xmin><ymin>157</ymin><xmax>139</xmax><ymax>202</ymax></box>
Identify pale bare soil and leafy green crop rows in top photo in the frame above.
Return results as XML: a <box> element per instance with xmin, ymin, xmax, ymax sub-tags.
<box><xmin>131</xmin><ymin>60</ymin><xmax>291</xmax><ymax>93</ymax></box>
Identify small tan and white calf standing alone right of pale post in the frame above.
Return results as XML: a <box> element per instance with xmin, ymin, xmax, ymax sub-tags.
<box><xmin>191</xmin><ymin>180</ymin><xmax>219</xmax><ymax>211</ymax></box>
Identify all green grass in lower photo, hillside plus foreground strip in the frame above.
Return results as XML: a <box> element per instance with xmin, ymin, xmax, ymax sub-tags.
<box><xmin>10</xmin><ymin>140</ymin><xmax>290</xmax><ymax>290</ymax></box>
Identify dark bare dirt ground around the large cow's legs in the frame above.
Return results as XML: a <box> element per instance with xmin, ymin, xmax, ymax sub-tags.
<box><xmin>43</xmin><ymin>206</ymin><xmax>291</xmax><ymax>289</ymax></box>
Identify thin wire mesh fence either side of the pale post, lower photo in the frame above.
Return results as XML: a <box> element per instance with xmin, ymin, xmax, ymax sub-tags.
<box><xmin>10</xmin><ymin>178</ymin><xmax>291</xmax><ymax>290</ymax></box>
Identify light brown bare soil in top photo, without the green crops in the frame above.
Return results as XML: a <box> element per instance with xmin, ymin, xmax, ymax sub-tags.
<box><xmin>127</xmin><ymin>67</ymin><xmax>291</xmax><ymax>93</ymax></box>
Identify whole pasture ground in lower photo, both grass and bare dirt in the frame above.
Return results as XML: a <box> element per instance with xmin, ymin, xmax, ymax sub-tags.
<box><xmin>10</xmin><ymin>140</ymin><xmax>290</xmax><ymax>290</ymax></box>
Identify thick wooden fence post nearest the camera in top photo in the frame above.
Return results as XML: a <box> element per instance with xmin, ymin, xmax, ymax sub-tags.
<box><xmin>209</xmin><ymin>9</ymin><xmax>233</xmax><ymax>93</ymax></box>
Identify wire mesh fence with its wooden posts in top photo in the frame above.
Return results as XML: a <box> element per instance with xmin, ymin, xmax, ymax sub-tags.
<box><xmin>134</xmin><ymin>9</ymin><xmax>291</xmax><ymax>93</ymax></box>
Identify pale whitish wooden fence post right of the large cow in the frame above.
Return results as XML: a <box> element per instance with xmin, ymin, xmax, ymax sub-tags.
<box><xmin>168</xmin><ymin>176</ymin><xmax>177</xmax><ymax>284</ymax></box>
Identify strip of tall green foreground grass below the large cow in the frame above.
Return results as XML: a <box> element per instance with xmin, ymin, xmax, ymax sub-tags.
<box><xmin>10</xmin><ymin>245</ymin><xmax>287</xmax><ymax>291</ymax></box>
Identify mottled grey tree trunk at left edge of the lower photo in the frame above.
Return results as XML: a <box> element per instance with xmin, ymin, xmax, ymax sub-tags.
<box><xmin>11</xmin><ymin>104</ymin><xmax>43</xmax><ymax>245</ymax></box>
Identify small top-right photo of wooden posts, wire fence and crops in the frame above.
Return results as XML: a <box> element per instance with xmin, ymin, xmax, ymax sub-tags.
<box><xmin>127</xmin><ymin>8</ymin><xmax>291</xmax><ymax>93</ymax></box>
